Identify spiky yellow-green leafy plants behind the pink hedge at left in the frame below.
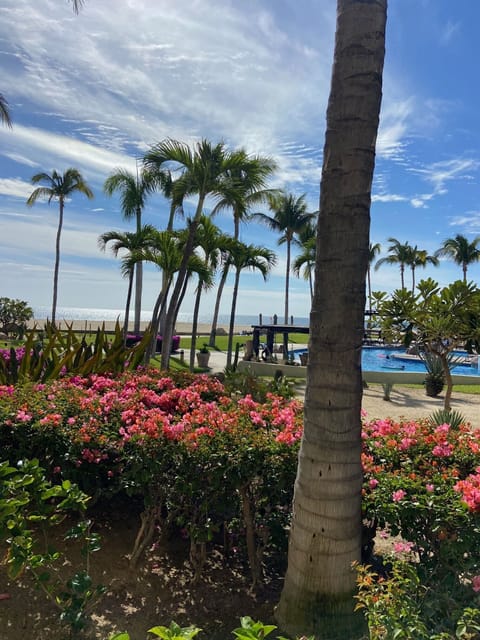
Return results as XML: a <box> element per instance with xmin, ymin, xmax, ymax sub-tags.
<box><xmin>0</xmin><ymin>323</ymin><xmax>149</xmax><ymax>384</ymax></box>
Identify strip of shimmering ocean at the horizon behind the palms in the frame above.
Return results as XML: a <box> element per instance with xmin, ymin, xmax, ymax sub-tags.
<box><xmin>32</xmin><ymin>306</ymin><xmax>309</xmax><ymax>327</ymax></box>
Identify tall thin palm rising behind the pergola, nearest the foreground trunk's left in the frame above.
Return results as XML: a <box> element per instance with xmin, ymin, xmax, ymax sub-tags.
<box><xmin>253</xmin><ymin>193</ymin><xmax>315</xmax><ymax>324</ymax></box>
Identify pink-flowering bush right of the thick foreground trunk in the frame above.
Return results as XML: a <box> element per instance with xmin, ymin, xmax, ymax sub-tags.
<box><xmin>363</xmin><ymin>420</ymin><xmax>480</xmax><ymax>638</ymax></box>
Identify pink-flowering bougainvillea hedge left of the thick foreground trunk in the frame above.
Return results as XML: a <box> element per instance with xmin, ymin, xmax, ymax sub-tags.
<box><xmin>0</xmin><ymin>369</ymin><xmax>302</xmax><ymax>580</ymax></box>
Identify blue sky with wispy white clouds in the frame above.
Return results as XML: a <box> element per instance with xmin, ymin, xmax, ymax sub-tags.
<box><xmin>0</xmin><ymin>0</ymin><xmax>480</xmax><ymax>317</ymax></box>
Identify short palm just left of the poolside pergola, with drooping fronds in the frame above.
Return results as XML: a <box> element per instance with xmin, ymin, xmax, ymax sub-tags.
<box><xmin>223</xmin><ymin>240</ymin><xmax>277</xmax><ymax>368</ymax></box>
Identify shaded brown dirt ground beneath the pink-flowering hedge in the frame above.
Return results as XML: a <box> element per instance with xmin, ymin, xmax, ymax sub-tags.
<box><xmin>0</xmin><ymin>512</ymin><xmax>281</xmax><ymax>640</ymax></box>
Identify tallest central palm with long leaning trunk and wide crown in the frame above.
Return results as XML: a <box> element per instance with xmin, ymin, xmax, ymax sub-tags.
<box><xmin>144</xmin><ymin>139</ymin><xmax>260</xmax><ymax>369</ymax></box>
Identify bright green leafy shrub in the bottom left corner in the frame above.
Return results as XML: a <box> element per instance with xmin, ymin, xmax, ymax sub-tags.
<box><xmin>0</xmin><ymin>459</ymin><xmax>104</xmax><ymax>631</ymax></box>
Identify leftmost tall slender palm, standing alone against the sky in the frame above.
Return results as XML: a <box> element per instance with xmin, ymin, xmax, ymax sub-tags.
<box><xmin>27</xmin><ymin>167</ymin><xmax>93</xmax><ymax>324</ymax></box>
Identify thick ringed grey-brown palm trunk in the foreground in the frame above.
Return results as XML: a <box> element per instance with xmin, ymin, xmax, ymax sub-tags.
<box><xmin>276</xmin><ymin>0</ymin><xmax>387</xmax><ymax>640</ymax></box>
